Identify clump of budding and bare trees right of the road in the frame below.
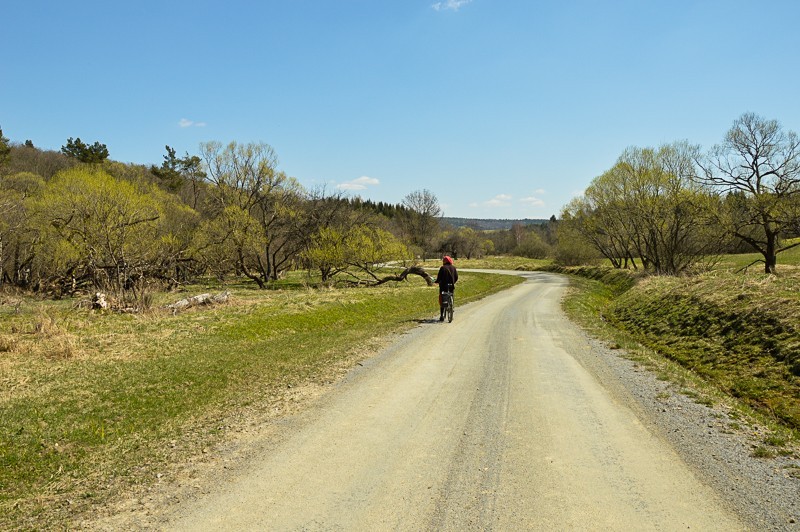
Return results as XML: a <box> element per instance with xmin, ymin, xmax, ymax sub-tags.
<box><xmin>561</xmin><ymin>113</ymin><xmax>800</xmax><ymax>274</ymax></box>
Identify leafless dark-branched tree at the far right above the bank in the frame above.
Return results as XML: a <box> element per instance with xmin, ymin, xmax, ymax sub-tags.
<box><xmin>696</xmin><ymin>113</ymin><xmax>800</xmax><ymax>273</ymax></box>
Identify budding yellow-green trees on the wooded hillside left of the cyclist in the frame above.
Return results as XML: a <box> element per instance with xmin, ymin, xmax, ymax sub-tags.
<box><xmin>0</xmin><ymin>131</ymin><xmax>506</xmax><ymax>299</ymax></box>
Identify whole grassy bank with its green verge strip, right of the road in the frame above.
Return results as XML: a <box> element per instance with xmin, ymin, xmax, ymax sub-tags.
<box><xmin>552</xmin><ymin>248</ymin><xmax>800</xmax><ymax>448</ymax></box>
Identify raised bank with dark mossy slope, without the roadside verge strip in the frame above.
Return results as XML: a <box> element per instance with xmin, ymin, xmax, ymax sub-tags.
<box><xmin>608</xmin><ymin>272</ymin><xmax>800</xmax><ymax>430</ymax></box>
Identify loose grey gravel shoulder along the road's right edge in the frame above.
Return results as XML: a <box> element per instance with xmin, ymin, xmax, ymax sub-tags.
<box><xmin>578</xmin><ymin>334</ymin><xmax>800</xmax><ymax>530</ymax></box>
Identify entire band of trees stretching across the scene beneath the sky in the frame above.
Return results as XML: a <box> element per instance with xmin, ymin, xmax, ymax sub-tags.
<box><xmin>0</xmin><ymin>113</ymin><xmax>788</xmax><ymax>297</ymax></box>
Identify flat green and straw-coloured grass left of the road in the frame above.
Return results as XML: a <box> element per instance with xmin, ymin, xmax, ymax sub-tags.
<box><xmin>0</xmin><ymin>274</ymin><xmax>520</xmax><ymax>529</ymax></box>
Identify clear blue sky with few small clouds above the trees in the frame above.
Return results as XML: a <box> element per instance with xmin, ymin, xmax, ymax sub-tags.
<box><xmin>0</xmin><ymin>0</ymin><xmax>800</xmax><ymax>218</ymax></box>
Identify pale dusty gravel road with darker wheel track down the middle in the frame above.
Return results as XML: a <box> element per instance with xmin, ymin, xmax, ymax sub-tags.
<box><xmin>164</xmin><ymin>273</ymin><xmax>746</xmax><ymax>531</ymax></box>
